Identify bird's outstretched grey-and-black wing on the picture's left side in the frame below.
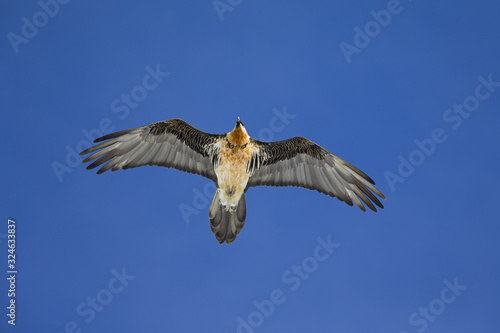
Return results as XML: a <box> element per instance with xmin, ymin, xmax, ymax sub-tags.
<box><xmin>80</xmin><ymin>119</ymin><xmax>224</xmax><ymax>181</ymax></box>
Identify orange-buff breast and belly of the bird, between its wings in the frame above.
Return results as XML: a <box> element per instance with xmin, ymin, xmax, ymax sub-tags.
<box><xmin>215</xmin><ymin>144</ymin><xmax>252</xmax><ymax>211</ymax></box>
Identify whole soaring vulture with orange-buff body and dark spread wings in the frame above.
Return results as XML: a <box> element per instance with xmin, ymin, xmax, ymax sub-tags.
<box><xmin>80</xmin><ymin>117</ymin><xmax>385</xmax><ymax>244</ymax></box>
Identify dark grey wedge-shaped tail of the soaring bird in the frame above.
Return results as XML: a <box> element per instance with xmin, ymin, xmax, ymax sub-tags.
<box><xmin>208</xmin><ymin>192</ymin><xmax>247</xmax><ymax>244</ymax></box>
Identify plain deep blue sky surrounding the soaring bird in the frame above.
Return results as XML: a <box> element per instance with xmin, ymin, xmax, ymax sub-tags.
<box><xmin>0</xmin><ymin>0</ymin><xmax>500</xmax><ymax>333</ymax></box>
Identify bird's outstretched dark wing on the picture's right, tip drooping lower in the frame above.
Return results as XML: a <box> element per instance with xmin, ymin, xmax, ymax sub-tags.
<box><xmin>248</xmin><ymin>137</ymin><xmax>385</xmax><ymax>212</ymax></box>
